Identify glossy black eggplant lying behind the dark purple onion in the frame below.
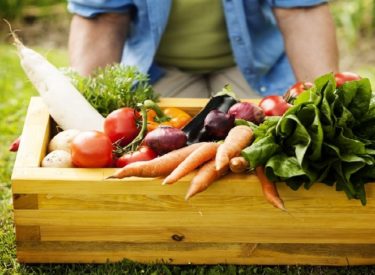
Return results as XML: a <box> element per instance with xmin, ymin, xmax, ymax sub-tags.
<box><xmin>182</xmin><ymin>92</ymin><xmax>238</xmax><ymax>144</ymax></box>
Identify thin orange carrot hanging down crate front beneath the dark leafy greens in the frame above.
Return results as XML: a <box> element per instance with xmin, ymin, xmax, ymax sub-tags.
<box><xmin>255</xmin><ymin>166</ymin><xmax>286</xmax><ymax>211</ymax></box>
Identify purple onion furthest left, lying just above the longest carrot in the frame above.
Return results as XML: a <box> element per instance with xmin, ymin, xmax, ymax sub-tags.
<box><xmin>142</xmin><ymin>126</ymin><xmax>187</xmax><ymax>155</ymax></box>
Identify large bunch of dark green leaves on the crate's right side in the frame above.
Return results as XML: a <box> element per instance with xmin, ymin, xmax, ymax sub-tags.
<box><xmin>242</xmin><ymin>74</ymin><xmax>375</xmax><ymax>205</ymax></box>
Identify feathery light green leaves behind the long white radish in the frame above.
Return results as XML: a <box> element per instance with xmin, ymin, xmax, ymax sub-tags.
<box><xmin>68</xmin><ymin>64</ymin><xmax>158</xmax><ymax>117</ymax></box>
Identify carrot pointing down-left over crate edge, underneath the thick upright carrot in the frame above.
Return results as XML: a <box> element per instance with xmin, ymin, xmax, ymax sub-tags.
<box><xmin>185</xmin><ymin>159</ymin><xmax>228</xmax><ymax>200</ymax></box>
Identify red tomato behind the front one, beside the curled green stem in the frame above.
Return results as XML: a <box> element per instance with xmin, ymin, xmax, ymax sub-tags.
<box><xmin>104</xmin><ymin>107</ymin><xmax>139</xmax><ymax>146</ymax></box>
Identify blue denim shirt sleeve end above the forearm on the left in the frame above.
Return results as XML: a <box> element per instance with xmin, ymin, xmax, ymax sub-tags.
<box><xmin>68</xmin><ymin>0</ymin><xmax>133</xmax><ymax>17</ymax></box>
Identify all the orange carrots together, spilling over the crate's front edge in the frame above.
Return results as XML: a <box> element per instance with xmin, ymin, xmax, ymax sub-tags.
<box><xmin>110</xmin><ymin>125</ymin><xmax>285</xmax><ymax>210</ymax></box>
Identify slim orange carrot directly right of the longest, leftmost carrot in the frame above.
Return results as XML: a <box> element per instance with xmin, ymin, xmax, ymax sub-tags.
<box><xmin>163</xmin><ymin>142</ymin><xmax>219</xmax><ymax>184</ymax></box>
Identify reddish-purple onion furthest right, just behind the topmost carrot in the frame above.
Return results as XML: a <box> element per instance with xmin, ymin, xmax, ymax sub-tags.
<box><xmin>228</xmin><ymin>102</ymin><xmax>265</xmax><ymax>124</ymax></box>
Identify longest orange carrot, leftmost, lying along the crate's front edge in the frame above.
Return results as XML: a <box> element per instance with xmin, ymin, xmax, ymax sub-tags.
<box><xmin>108</xmin><ymin>142</ymin><xmax>205</xmax><ymax>179</ymax></box>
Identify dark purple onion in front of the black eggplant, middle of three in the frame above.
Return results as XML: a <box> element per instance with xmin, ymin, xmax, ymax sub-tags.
<box><xmin>204</xmin><ymin>110</ymin><xmax>234</xmax><ymax>139</ymax></box>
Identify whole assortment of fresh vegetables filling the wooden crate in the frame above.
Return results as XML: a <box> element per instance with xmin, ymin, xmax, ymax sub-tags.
<box><xmin>10</xmin><ymin>33</ymin><xmax>375</xmax><ymax>210</ymax></box>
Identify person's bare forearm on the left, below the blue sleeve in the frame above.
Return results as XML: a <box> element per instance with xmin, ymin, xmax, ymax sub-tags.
<box><xmin>69</xmin><ymin>14</ymin><xmax>130</xmax><ymax>75</ymax></box>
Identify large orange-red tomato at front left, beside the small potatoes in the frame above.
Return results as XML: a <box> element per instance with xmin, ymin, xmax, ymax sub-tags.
<box><xmin>70</xmin><ymin>131</ymin><xmax>112</xmax><ymax>168</ymax></box>
